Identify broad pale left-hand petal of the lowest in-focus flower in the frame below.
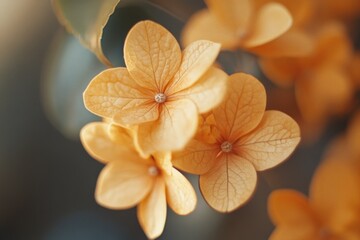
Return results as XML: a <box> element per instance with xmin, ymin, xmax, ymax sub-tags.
<box><xmin>95</xmin><ymin>160</ymin><xmax>154</xmax><ymax>209</ymax></box>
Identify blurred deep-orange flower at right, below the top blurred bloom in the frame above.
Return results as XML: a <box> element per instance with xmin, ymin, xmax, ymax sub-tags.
<box><xmin>260</xmin><ymin>23</ymin><xmax>353</xmax><ymax>127</ymax></box>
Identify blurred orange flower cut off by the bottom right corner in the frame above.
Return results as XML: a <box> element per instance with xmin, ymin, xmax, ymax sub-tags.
<box><xmin>268</xmin><ymin>157</ymin><xmax>360</xmax><ymax>240</ymax></box>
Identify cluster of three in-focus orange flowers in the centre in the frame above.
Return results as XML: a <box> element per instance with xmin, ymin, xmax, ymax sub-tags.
<box><xmin>81</xmin><ymin>21</ymin><xmax>300</xmax><ymax>238</ymax></box>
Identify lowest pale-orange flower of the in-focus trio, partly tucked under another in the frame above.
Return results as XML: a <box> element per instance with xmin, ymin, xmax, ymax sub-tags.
<box><xmin>80</xmin><ymin>122</ymin><xmax>196</xmax><ymax>239</ymax></box>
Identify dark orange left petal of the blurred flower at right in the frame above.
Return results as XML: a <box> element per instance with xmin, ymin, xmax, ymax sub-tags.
<box><xmin>260</xmin><ymin>57</ymin><xmax>302</xmax><ymax>87</ymax></box>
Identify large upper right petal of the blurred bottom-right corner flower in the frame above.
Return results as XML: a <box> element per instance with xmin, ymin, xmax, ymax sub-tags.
<box><xmin>310</xmin><ymin>156</ymin><xmax>360</xmax><ymax>231</ymax></box>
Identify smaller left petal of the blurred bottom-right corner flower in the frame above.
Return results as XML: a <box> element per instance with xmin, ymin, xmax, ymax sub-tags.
<box><xmin>268</xmin><ymin>189</ymin><xmax>320</xmax><ymax>240</ymax></box>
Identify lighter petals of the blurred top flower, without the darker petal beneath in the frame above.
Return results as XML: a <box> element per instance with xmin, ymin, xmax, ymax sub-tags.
<box><xmin>183</xmin><ymin>0</ymin><xmax>292</xmax><ymax>51</ymax></box>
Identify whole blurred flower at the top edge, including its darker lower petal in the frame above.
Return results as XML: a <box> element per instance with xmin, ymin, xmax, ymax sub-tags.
<box><xmin>182</xmin><ymin>0</ymin><xmax>312</xmax><ymax>57</ymax></box>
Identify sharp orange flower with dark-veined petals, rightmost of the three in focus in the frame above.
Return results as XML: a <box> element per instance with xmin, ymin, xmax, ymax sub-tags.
<box><xmin>173</xmin><ymin>73</ymin><xmax>300</xmax><ymax>212</ymax></box>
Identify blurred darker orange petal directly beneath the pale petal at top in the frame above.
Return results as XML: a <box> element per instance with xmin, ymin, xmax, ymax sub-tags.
<box><xmin>249</xmin><ymin>29</ymin><xmax>314</xmax><ymax>58</ymax></box>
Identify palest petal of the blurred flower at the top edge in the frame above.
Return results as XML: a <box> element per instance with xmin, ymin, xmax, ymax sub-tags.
<box><xmin>244</xmin><ymin>2</ymin><xmax>292</xmax><ymax>48</ymax></box>
